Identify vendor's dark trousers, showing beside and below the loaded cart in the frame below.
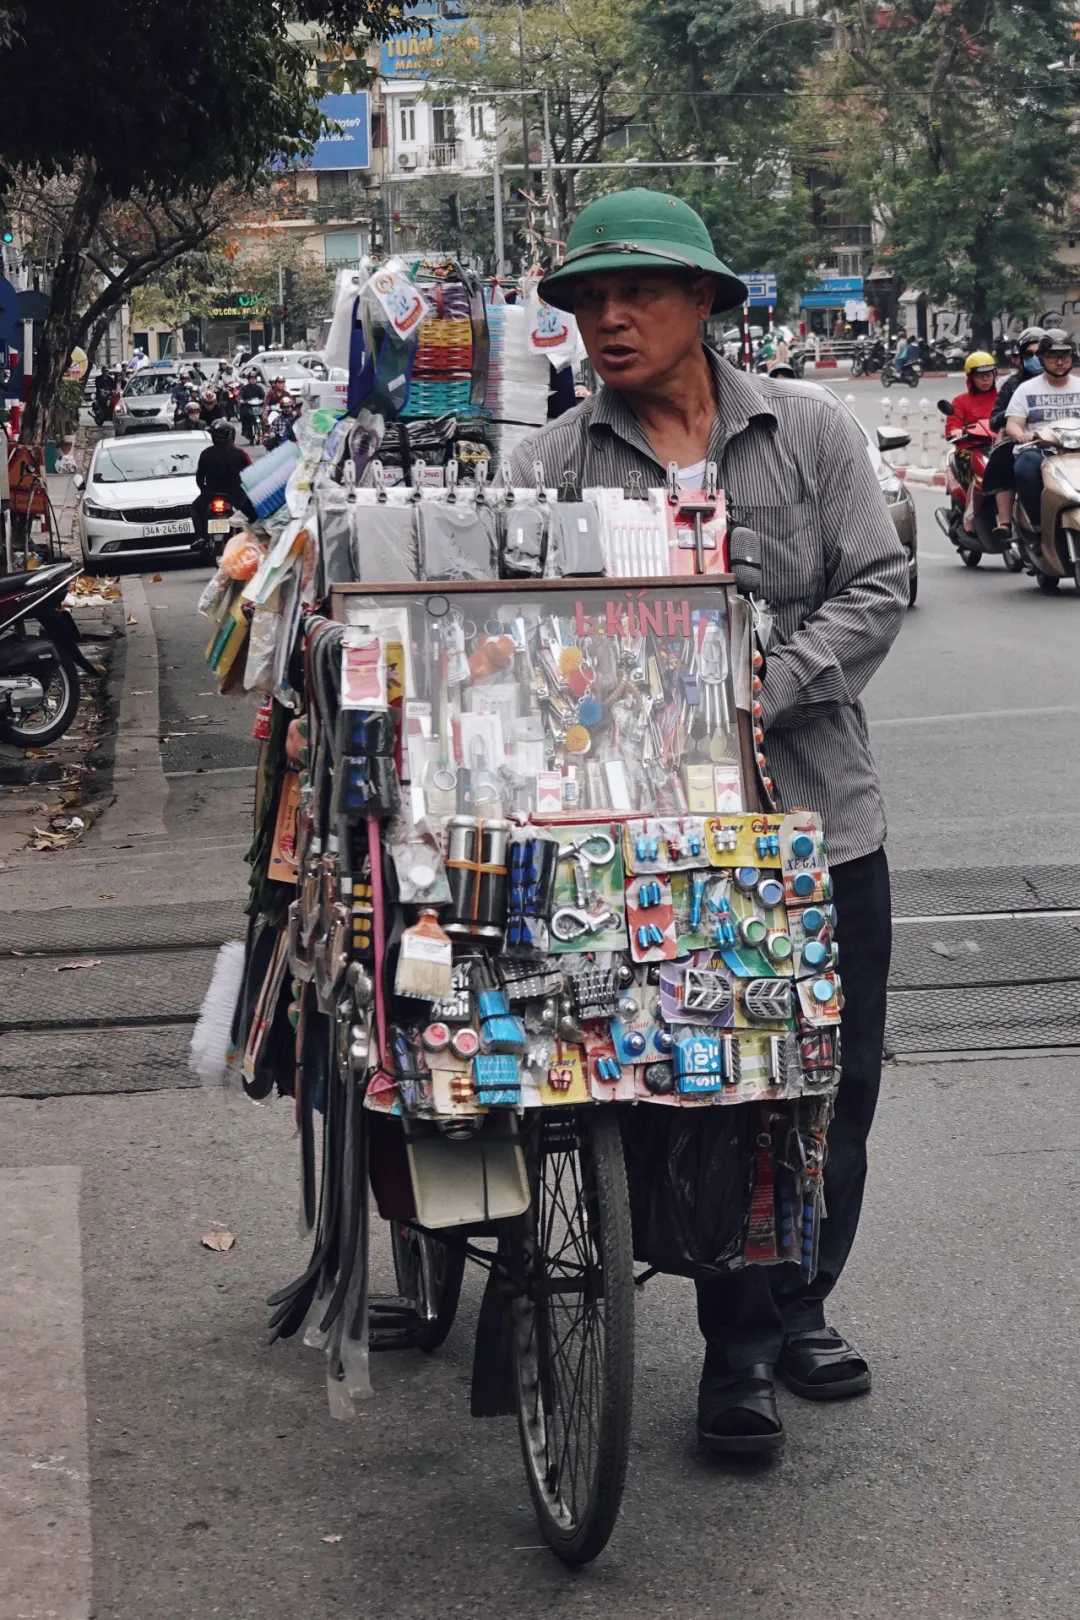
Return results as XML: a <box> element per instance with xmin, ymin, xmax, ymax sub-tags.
<box><xmin>698</xmin><ymin>849</ymin><xmax>892</xmax><ymax>1374</ymax></box>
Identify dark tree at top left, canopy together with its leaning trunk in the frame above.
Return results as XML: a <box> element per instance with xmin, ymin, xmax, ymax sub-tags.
<box><xmin>0</xmin><ymin>0</ymin><xmax>402</xmax><ymax>442</ymax></box>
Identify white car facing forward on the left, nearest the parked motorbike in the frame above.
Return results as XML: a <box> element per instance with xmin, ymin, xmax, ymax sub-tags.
<box><xmin>74</xmin><ymin>429</ymin><xmax>210</xmax><ymax>573</ymax></box>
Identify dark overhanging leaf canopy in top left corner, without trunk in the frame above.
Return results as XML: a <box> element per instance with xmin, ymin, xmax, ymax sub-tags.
<box><xmin>0</xmin><ymin>0</ymin><xmax>400</xmax><ymax>198</ymax></box>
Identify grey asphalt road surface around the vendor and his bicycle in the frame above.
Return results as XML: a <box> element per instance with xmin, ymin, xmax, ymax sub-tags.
<box><xmin>0</xmin><ymin>372</ymin><xmax>1080</xmax><ymax>1620</ymax></box>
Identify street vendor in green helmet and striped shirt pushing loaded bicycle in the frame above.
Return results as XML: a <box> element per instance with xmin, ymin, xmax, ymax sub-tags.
<box><xmin>510</xmin><ymin>190</ymin><xmax>908</xmax><ymax>1452</ymax></box>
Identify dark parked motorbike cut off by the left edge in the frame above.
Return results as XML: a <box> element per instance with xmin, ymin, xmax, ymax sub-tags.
<box><xmin>0</xmin><ymin>562</ymin><xmax>100</xmax><ymax>748</ymax></box>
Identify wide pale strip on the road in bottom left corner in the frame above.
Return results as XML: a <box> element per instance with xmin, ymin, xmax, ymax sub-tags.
<box><xmin>0</xmin><ymin>1165</ymin><xmax>91</xmax><ymax>1620</ymax></box>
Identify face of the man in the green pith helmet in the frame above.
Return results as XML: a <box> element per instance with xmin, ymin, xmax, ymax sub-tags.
<box><xmin>573</xmin><ymin>269</ymin><xmax>712</xmax><ymax>392</ymax></box>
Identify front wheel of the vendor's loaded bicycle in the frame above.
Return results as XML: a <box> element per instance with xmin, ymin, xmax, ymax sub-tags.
<box><xmin>513</xmin><ymin>1108</ymin><xmax>633</xmax><ymax>1565</ymax></box>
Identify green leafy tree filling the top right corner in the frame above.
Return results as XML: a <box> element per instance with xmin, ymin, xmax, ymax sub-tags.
<box><xmin>819</xmin><ymin>0</ymin><xmax>1077</xmax><ymax>347</ymax></box>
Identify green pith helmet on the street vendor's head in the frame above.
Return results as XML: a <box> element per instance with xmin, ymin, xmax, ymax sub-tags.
<box><xmin>539</xmin><ymin>186</ymin><xmax>746</xmax><ymax>313</ymax></box>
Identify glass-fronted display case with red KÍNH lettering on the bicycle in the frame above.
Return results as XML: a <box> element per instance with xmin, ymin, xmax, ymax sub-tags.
<box><xmin>334</xmin><ymin>575</ymin><xmax>756</xmax><ymax>821</ymax></box>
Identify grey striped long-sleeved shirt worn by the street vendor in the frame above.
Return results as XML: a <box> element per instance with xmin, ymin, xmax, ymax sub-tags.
<box><xmin>510</xmin><ymin>348</ymin><xmax>908</xmax><ymax>863</ymax></box>
